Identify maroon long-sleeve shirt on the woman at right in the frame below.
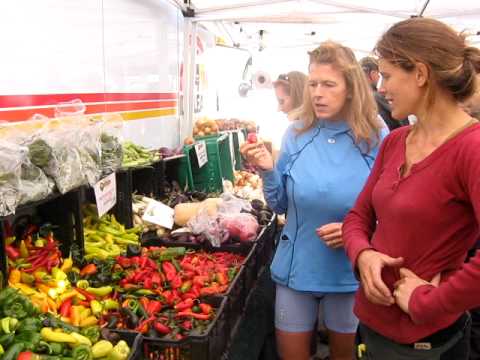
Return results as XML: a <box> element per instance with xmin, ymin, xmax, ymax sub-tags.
<box><xmin>343</xmin><ymin>124</ymin><xmax>480</xmax><ymax>343</ymax></box>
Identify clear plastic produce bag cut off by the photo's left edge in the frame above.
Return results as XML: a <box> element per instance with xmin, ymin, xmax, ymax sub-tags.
<box><xmin>0</xmin><ymin>141</ymin><xmax>22</xmax><ymax>216</ymax></box>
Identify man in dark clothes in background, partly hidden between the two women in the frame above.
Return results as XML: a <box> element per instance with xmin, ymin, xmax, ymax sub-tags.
<box><xmin>360</xmin><ymin>57</ymin><xmax>409</xmax><ymax>131</ymax></box>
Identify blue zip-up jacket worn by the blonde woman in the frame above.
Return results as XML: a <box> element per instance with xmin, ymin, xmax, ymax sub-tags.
<box><xmin>262</xmin><ymin>121</ymin><xmax>388</xmax><ymax>293</ymax></box>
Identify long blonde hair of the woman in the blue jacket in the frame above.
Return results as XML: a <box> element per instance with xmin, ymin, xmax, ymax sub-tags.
<box><xmin>291</xmin><ymin>41</ymin><xmax>382</xmax><ymax>150</ymax></box>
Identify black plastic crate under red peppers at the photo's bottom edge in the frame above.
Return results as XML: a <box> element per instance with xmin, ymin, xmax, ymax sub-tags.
<box><xmin>143</xmin><ymin>297</ymin><xmax>231</xmax><ymax>360</ymax></box>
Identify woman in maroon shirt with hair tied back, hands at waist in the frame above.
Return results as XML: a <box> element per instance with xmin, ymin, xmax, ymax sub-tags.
<box><xmin>343</xmin><ymin>18</ymin><xmax>480</xmax><ymax>360</ymax></box>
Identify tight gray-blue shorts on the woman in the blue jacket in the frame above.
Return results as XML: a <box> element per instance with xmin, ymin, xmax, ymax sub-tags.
<box><xmin>275</xmin><ymin>284</ymin><xmax>358</xmax><ymax>334</ymax></box>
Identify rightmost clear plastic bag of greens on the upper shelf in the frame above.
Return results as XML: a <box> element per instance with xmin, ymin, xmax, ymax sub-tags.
<box><xmin>100</xmin><ymin>115</ymin><xmax>123</xmax><ymax>175</ymax></box>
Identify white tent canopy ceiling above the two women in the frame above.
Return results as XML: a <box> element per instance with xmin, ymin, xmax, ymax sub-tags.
<box><xmin>187</xmin><ymin>0</ymin><xmax>480</xmax><ymax>53</ymax></box>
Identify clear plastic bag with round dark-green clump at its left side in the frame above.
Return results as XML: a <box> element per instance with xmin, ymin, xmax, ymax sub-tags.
<box><xmin>28</xmin><ymin>126</ymin><xmax>87</xmax><ymax>194</ymax></box>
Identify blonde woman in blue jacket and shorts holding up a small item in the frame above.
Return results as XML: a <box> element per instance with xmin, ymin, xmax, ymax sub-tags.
<box><xmin>242</xmin><ymin>42</ymin><xmax>388</xmax><ymax>360</ymax></box>
